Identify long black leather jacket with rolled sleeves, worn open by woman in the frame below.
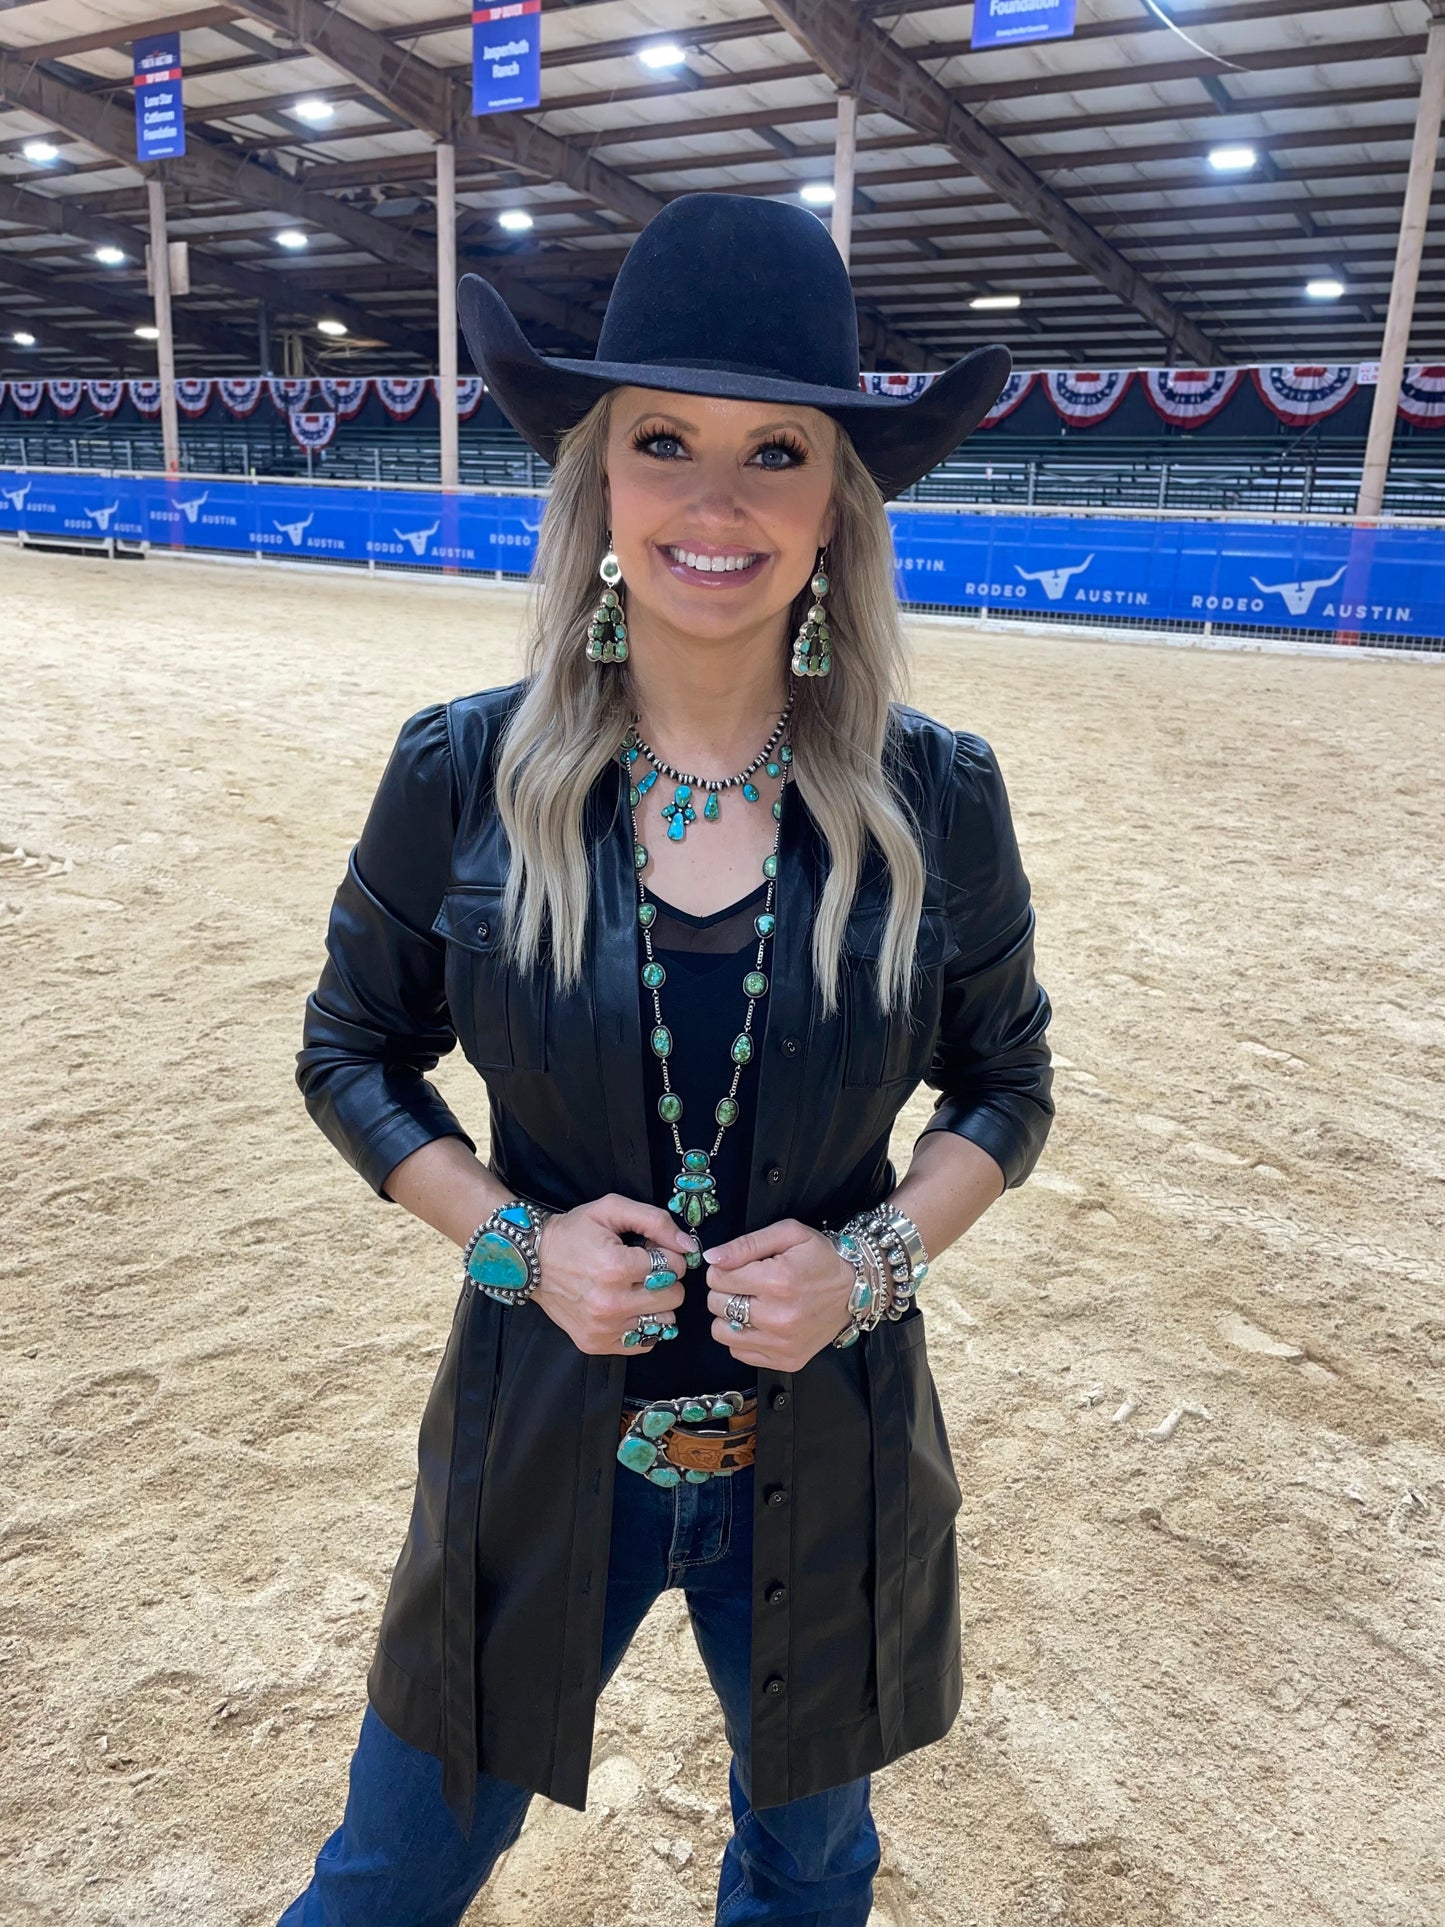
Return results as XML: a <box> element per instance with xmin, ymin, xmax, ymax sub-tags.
<box><xmin>297</xmin><ymin>684</ymin><xmax>1054</xmax><ymax>1829</ymax></box>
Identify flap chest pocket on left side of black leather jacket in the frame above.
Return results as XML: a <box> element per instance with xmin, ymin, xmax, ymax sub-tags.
<box><xmin>432</xmin><ymin>884</ymin><xmax>551</xmax><ymax>1071</ymax></box>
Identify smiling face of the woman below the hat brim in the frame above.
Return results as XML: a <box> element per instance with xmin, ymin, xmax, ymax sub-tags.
<box><xmin>607</xmin><ymin>387</ymin><xmax>838</xmax><ymax>638</ymax></box>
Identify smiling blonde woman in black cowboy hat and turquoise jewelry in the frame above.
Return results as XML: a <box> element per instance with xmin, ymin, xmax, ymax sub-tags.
<box><xmin>283</xmin><ymin>195</ymin><xmax>1052</xmax><ymax>1927</ymax></box>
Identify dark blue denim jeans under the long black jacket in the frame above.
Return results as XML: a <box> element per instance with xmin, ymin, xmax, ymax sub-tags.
<box><xmin>279</xmin><ymin>1466</ymin><xmax>879</xmax><ymax>1927</ymax></box>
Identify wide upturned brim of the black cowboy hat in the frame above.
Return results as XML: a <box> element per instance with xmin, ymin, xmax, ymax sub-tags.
<box><xmin>457</xmin><ymin>274</ymin><xmax>1013</xmax><ymax>501</ymax></box>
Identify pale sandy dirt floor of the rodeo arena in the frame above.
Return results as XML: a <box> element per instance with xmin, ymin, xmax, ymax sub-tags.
<box><xmin>0</xmin><ymin>549</ymin><xmax>1445</xmax><ymax>1927</ymax></box>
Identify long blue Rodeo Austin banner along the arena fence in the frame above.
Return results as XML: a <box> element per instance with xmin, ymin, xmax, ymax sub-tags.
<box><xmin>0</xmin><ymin>468</ymin><xmax>1445</xmax><ymax>640</ymax></box>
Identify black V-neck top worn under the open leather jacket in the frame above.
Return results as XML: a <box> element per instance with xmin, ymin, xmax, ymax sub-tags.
<box><xmin>626</xmin><ymin>883</ymin><xmax>773</xmax><ymax>1399</ymax></box>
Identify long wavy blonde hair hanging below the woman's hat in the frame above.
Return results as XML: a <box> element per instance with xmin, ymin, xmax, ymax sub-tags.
<box><xmin>495</xmin><ymin>389</ymin><xmax>923</xmax><ymax>1012</ymax></box>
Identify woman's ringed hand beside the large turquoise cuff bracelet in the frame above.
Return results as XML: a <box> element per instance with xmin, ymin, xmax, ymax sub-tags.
<box><xmin>532</xmin><ymin>1191</ymin><xmax>696</xmax><ymax>1357</ymax></box>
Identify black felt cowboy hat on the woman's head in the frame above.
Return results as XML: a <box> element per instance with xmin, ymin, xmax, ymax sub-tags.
<box><xmin>457</xmin><ymin>195</ymin><xmax>1012</xmax><ymax>499</ymax></box>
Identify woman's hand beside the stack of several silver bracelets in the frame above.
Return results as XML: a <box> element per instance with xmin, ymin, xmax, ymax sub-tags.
<box><xmin>703</xmin><ymin>1218</ymin><xmax>854</xmax><ymax>1372</ymax></box>
